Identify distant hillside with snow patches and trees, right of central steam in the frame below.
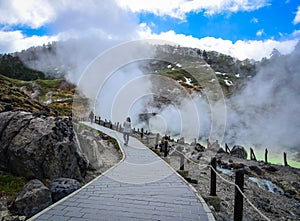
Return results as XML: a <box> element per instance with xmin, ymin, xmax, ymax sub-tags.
<box><xmin>151</xmin><ymin>46</ymin><xmax>259</xmax><ymax>96</ymax></box>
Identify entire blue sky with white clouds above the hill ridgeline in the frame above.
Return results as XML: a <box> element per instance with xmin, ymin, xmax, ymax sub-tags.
<box><xmin>0</xmin><ymin>0</ymin><xmax>300</xmax><ymax>60</ymax></box>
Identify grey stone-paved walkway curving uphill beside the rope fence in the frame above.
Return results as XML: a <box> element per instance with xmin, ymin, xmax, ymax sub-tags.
<box><xmin>30</xmin><ymin>123</ymin><xmax>214</xmax><ymax>221</ymax></box>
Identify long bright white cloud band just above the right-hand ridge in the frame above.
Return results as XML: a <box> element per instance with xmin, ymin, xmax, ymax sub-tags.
<box><xmin>142</xmin><ymin>30</ymin><xmax>298</xmax><ymax>60</ymax></box>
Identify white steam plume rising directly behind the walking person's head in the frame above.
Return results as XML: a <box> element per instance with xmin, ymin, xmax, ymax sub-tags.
<box><xmin>95</xmin><ymin>63</ymin><xmax>152</xmax><ymax>126</ymax></box>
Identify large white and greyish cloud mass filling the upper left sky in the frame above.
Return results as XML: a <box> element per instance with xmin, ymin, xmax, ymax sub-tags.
<box><xmin>0</xmin><ymin>0</ymin><xmax>140</xmax><ymax>53</ymax></box>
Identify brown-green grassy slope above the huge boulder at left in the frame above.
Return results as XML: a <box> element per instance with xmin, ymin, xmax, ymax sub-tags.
<box><xmin>0</xmin><ymin>75</ymin><xmax>82</xmax><ymax>116</ymax></box>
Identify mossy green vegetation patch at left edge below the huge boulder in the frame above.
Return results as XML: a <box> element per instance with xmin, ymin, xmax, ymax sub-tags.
<box><xmin>0</xmin><ymin>175</ymin><xmax>27</xmax><ymax>196</ymax></box>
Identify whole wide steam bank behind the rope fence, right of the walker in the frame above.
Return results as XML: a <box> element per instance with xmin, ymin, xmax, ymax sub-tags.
<box><xmin>142</xmin><ymin>43</ymin><xmax>300</xmax><ymax>161</ymax></box>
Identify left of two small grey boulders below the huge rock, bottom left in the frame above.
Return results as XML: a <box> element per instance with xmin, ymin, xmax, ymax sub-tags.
<box><xmin>14</xmin><ymin>179</ymin><xmax>52</xmax><ymax>217</ymax></box>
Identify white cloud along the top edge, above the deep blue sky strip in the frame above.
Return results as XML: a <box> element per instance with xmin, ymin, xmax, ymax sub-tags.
<box><xmin>117</xmin><ymin>0</ymin><xmax>269</xmax><ymax>19</ymax></box>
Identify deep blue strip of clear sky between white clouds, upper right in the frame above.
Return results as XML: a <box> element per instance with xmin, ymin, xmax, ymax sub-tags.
<box><xmin>139</xmin><ymin>0</ymin><xmax>300</xmax><ymax>41</ymax></box>
